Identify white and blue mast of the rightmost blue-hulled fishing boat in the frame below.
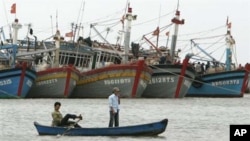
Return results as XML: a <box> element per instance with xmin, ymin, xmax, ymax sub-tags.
<box><xmin>225</xmin><ymin>23</ymin><xmax>235</xmax><ymax>71</ymax></box>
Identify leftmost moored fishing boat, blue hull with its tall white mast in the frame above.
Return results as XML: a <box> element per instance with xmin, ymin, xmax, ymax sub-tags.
<box><xmin>0</xmin><ymin>19</ymin><xmax>37</xmax><ymax>98</ymax></box>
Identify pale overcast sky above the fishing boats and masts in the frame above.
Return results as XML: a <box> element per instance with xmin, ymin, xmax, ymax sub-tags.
<box><xmin>0</xmin><ymin>0</ymin><xmax>250</xmax><ymax>64</ymax></box>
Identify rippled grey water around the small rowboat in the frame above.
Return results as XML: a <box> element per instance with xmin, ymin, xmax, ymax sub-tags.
<box><xmin>0</xmin><ymin>95</ymin><xmax>250</xmax><ymax>141</ymax></box>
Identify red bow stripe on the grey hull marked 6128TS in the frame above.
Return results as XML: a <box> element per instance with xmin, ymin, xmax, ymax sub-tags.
<box><xmin>175</xmin><ymin>58</ymin><xmax>189</xmax><ymax>98</ymax></box>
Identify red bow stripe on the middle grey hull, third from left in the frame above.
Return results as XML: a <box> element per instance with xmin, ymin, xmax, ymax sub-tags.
<box><xmin>131</xmin><ymin>60</ymin><xmax>144</xmax><ymax>97</ymax></box>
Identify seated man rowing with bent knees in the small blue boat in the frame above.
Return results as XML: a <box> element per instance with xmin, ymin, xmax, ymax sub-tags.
<box><xmin>52</xmin><ymin>102</ymin><xmax>82</xmax><ymax>127</ymax></box>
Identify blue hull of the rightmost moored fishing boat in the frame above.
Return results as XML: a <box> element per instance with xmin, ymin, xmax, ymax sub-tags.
<box><xmin>186</xmin><ymin>70</ymin><xmax>246</xmax><ymax>97</ymax></box>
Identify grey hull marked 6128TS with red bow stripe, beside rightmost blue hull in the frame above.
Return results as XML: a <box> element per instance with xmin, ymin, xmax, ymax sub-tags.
<box><xmin>142</xmin><ymin>64</ymin><xmax>195</xmax><ymax>98</ymax></box>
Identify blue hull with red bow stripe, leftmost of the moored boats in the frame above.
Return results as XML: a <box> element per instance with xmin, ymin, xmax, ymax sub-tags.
<box><xmin>0</xmin><ymin>68</ymin><xmax>36</xmax><ymax>98</ymax></box>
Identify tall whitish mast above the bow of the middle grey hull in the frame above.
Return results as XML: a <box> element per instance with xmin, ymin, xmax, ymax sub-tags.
<box><xmin>123</xmin><ymin>5</ymin><xmax>137</xmax><ymax>63</ymax></box>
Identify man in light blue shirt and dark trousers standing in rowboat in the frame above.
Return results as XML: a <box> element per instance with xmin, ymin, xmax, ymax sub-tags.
<box><xmin>108</xmin><ymin>87</ymin><xmax>120</xmax><ymax>127</ymax></box>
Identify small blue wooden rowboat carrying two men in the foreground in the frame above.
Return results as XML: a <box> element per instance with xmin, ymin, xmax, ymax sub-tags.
<box><xmin>34</xmin><ymin>119</ymin><xmax>168</xmax><ymax>136</ymax></box>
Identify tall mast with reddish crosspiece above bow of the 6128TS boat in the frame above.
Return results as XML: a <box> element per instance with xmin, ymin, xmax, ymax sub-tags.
<box><xmin>170</xmin><ymin>4</ymin><xmax>184</xmax><ymax>63</ymax></box>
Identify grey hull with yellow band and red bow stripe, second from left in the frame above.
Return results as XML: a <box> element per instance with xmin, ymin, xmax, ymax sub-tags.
<box><xmin>27</xmin><ymin>67</ymin><xmax>80</xmax><ymax>98</ymax></box>
